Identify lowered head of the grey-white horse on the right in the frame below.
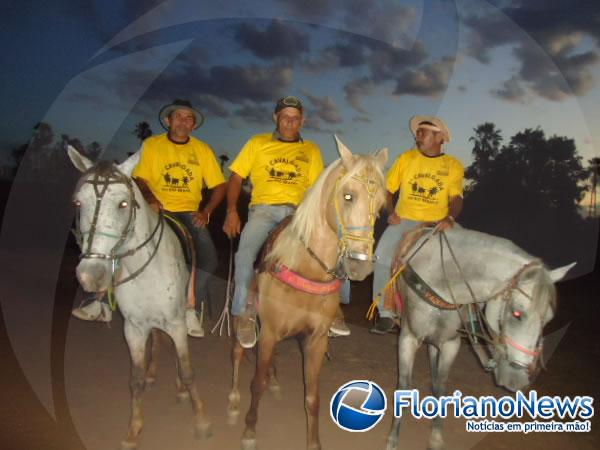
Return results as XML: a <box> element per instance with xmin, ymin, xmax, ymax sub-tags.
<box><xmin>485</xmin><ymin>260</ymin><xmax>575</xmax><ymax>391</ymax></box>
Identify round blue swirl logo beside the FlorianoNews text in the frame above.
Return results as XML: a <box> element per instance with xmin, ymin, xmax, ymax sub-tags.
<box><xmin>329</xmin><ymin>380</ymin><xmax>387</xmax><ymax>432</ymax></box>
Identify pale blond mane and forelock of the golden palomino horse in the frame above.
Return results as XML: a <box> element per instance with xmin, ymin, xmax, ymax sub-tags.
<box><xmin>265</xmin><ymin>155</ymin><xmax>383</xmax><ymax>267</ymax></box>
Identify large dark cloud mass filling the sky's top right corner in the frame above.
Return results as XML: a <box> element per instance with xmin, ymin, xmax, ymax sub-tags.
<box><xmin>465</xmin><ymin>0</ymin><xmax>600</xmax><ymax>101</ymax></box>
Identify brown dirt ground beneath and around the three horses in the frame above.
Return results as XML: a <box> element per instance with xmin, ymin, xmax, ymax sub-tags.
<box><xmin>0</xmin><ymin>243</ymin><xmax>600</xmax><ymax>450</ymax></box>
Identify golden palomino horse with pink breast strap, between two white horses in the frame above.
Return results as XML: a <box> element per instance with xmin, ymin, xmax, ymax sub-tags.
<box><xmin>229</xmin><ymin>138</ymin><xmax>387</xmax><ymax>450</ymax></box>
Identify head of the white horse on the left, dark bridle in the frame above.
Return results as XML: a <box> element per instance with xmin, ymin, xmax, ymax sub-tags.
<box><xmin>67</xmin><ymin>146</ymin><xmax>140</xmax><ymax>292</ymax></box>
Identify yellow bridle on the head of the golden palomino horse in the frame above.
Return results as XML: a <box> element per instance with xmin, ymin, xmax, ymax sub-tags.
<box><xmin>305</xmin><ymin>165</ymin><xmax>378</xmax><ymax>278</ymax></box>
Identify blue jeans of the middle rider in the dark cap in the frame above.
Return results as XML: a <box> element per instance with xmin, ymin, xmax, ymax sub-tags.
<box><xmin>231</xmin><ymin>205</ymin><xmax>350</xmax><ymax>316</ymax></box>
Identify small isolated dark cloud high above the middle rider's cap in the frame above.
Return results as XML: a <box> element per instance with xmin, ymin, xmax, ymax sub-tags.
<box><xmin>234</xmin><ymin>20</ymin><xmax>310</xmax><ymax>60</ymax></box>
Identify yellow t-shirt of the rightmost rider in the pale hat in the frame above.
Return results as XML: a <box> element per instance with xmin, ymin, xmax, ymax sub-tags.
<box><xmin>386</xmin><ymin>149</ymin><xmax>464</xmax><ymax>222</ymax></box>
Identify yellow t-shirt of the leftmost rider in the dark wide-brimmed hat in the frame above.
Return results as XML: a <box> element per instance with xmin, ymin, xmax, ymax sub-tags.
<box><xmin>132</xmin><ymin>134</ymin><xmax>225</xmax><ymax>212</ymax></box>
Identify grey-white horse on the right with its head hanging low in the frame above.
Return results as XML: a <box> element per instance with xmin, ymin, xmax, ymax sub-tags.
<box><xmin>387</xmin><ymin>226</ymin><xmax>574</xmax><ymax>450</ymax></box>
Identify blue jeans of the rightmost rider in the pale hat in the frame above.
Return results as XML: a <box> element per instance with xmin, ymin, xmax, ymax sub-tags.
<box><xmin>372</xmin><ymin>219</ymin><xmax>422</xmax><ymax>318</ymax></box>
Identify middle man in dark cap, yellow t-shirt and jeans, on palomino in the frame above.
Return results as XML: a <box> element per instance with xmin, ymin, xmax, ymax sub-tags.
<box><xmin>223</xmin><ymin>96</ymin><xmax>350</xmax><ymax>348</ymax></box>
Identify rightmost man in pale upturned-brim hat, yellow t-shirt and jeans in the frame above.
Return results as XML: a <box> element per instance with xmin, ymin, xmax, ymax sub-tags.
<box><xmin>370</xmin><ymin>116</ymin><xmax>464</xmax><ymax>334</ymax></box>
